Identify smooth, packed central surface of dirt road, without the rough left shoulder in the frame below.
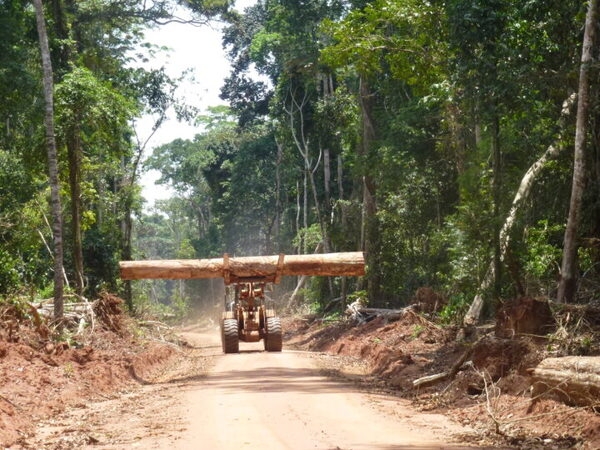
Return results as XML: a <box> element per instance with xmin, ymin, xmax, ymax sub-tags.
<box><xmin>129</xmin><ymin>334</ymin><xmax>486</xmax><ymax>450</ymax></box>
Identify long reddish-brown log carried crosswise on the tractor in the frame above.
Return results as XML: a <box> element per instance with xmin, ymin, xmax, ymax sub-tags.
<box><xmin>119</xmin><ymin>252</ymin><xmax>365</xmax><ymax>284</ymax></box>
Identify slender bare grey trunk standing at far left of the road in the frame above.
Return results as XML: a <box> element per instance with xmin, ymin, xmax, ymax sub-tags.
<box><xmin>33</xmin><ymin>0</ymin><xmax>64</xmax><ymax>324</ymax></box>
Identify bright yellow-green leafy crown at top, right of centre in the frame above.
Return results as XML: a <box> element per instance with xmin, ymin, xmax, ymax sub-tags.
<box><xmin>321</xmin><ymin>0</ymin><xmax>447</xmax><ymax>89</ymax></box>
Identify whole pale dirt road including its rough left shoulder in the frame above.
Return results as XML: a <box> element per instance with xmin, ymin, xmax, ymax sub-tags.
<box><xmin>25</xmin><ymin>333</ymin><xmax>490</xmax><ymax>450</ymax></box>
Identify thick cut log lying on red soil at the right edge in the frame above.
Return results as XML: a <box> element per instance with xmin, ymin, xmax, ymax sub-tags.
<box><xmin>528</xmin><ymin>356</ymin><xmax>600</xmax><ymax>406</ymax></box>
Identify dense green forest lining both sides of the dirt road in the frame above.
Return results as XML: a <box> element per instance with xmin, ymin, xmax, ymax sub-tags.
<box><xmin>0</xmin><ymin>0</ymin><xmax>600</xmax><ymax>317</ymax></box>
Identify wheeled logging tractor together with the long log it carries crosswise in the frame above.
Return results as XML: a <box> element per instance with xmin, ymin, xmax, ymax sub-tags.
<box><xmin>119</xmin><ymin>252</ymin><xmax>365</xmax><ymax>353</ymax></box>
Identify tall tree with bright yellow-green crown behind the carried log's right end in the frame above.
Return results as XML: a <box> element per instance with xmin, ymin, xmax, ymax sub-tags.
<box><xmin>321</xmin><ymin>0</ymin><xmax>454</xmax><ymax>304</ymax></box>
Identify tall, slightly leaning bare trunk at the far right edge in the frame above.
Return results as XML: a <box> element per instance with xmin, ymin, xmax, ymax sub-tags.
<box><xmin>557</xmin><ymin>0</ymin><xmax>598</xmax><ymax>303</ymax></box>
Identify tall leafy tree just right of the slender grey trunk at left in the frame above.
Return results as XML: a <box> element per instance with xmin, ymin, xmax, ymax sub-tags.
<box><xmin>38</xmin><ymin>0</ymin><xmax>211</xmax><ymax>304</ymax></box>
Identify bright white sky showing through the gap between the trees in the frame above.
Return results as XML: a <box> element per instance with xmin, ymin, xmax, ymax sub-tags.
<box><xmin>136</xmin><ymin>0</ymin><xmax>255</xmax><ymax>207</ymax></box>
